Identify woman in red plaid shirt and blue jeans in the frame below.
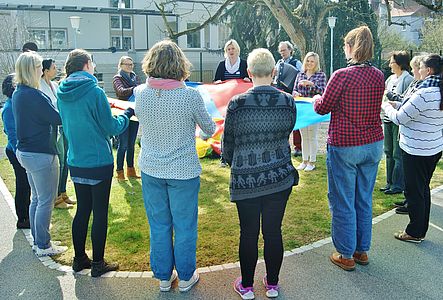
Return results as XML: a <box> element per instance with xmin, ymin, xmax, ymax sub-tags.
<box><xmin>314</xmin><ymin>26</ymin><xmax>385</xmax><ymax>271</ymax></box>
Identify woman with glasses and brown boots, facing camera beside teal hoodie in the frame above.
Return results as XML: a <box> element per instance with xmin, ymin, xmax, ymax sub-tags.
<box><xmin>112</xmin><ymin>56</ymin><xmax>140</xmax><ymax>180</ymax></box>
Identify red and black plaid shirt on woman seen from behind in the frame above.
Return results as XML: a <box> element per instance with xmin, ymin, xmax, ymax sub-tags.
<box><xmin>314</xmin><ymin>64</ymin><xmax>385</xmax><ymax>147</ymax></box>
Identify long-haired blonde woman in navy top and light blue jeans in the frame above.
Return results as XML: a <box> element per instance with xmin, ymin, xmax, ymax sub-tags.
<box><xmin>12</xmin><ymin>52</ymin><xmax>68</xmax><ymax>256</ymax></box>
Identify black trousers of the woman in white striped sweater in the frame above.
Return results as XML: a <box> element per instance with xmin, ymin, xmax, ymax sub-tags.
<box><xmin>402</xmin><ymin>150</ymin><xmax>442</xmax><ymax>238</ymax></box>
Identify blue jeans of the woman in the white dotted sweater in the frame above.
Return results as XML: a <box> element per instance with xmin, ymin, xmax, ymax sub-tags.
<box><xmin>142</xmin><ymin>172</ymin><xmax>200</xmax><ymax>280</ymax></box>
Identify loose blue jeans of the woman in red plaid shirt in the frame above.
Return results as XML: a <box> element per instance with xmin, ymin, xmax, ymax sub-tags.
<box><xmin>326</xmin><ymin>141</ymin><xmax>383</xmax><ymax>258</ymax></box>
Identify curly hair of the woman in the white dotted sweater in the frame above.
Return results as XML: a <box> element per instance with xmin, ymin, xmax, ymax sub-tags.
<box><xmin>142</xmin><ymin>40</ymin><xmax>192</xmax><ymax>81</ymax></box>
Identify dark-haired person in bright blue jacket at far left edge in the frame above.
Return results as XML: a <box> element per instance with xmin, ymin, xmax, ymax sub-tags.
<box><xmin>2</xmin><ymin>74</ymin><xmax>31</xmax><ymax>229</ymax></box>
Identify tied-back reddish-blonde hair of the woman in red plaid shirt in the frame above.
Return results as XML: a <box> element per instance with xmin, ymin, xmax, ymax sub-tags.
<box><xmin>345</xmin><ymin>26</ymin><xmax>374</xmax><ymax>63</ymax></box>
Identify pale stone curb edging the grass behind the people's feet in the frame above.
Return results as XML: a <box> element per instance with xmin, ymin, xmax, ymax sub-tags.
<box><xmin>0</xmin><ymin>177</ymin><xmax>443</xmax><ymax>278</ymax></box>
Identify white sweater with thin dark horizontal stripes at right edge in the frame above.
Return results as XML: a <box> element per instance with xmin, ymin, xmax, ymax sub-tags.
<box><xmin>382</xmin><ymin>87</ymin><xmax>443</xmax><ymax>156</ymax></box>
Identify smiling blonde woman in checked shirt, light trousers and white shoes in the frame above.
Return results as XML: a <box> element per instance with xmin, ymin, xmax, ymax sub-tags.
<box><xmin>293</xmin><ymin>52</ymin><xmax>326</xmax><ymax>171</ymax></box>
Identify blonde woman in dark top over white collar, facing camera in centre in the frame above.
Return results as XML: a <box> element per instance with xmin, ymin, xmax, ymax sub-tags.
<box><xmin>214</xmin><ymin>40</ymin><xmax>251</xmax><ymax>83</ymax></box>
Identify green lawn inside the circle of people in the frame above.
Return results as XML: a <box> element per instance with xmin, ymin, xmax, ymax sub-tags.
<box><xmin>0</xmin><ymin>125</ymin><xmax>443</xmax><ymax>271</ymax></box>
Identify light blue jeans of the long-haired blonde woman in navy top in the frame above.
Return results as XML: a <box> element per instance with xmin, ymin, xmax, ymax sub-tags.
<box><xmin>16</xmin><ymin>150</ymin><xmax>60</xmax><ymax>249</ymax></box>
